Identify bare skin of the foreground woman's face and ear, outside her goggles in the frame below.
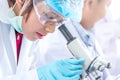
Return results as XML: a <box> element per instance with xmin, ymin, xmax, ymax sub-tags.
<box><xmin>10</xmin><ymin>0</ymin><xmax>62</xmax><ymax>41</ymax></box>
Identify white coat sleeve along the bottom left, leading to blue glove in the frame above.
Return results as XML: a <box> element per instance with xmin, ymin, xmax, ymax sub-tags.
<box><xmin>0</xmin><ymin>69</ymin><xmax>39</xmax><ymax>80</ymax></box>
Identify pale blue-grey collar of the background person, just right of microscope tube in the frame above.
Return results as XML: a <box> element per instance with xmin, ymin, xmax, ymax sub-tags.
<box><xmin>73</xmin><ymin>22</ymin><xmax>98</xmax><ymax>57</ymax></box>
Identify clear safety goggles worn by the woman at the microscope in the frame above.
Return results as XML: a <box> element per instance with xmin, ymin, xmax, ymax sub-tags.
<box><xmin>33</xmin><ymin>0</ymin><xmax>66</xmax><ymax>26</ymax></box>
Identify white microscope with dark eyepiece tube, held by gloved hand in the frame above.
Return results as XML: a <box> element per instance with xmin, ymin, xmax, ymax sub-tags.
<box><xmin>58</xmin><ymin>24</ymin><xmax>110</xmax><ymax>80</ymax></box>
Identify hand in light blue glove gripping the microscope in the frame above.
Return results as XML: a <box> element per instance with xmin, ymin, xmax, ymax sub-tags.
<box><xmin>37</xmin><ymin>59</ymin><xmax>84</xmax><ymax>80</ymax></box>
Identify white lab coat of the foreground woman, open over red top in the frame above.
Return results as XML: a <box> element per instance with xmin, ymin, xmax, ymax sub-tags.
<box><xmin>0</xmin><ymin>22</ymin><xmax>43</xmax><ymax>80</ymax></box>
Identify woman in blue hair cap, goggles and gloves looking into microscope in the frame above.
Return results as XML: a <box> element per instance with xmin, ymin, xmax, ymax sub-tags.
<box><xmin>0</xmin><ymin>0</ymin><xmax>84</xmax><ymax>80</ymax></box>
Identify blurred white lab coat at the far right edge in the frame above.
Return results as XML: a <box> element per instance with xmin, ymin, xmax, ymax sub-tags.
<box><xmin>95</xmin><ymin>20</ymin><xmax>120</xmax><ymax>75</ymax></box>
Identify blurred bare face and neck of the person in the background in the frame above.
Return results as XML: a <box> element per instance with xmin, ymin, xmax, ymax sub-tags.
<box><xmin>80</xmin><ymin>0</ymin><xmax>111</xmax><ymax>30</ymax></box>
